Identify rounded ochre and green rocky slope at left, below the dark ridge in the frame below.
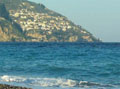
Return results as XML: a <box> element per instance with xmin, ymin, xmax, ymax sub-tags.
<box><xmin>0</xmin><ymin>17</ymin><xmax>25</xmax><ymax>42</ymax></box>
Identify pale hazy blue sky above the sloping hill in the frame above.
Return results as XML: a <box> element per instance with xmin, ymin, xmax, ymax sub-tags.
<box><xmin>30</xmin><ymin>0</ymin><xmax>120</xmax><ymax>42</ymax></box>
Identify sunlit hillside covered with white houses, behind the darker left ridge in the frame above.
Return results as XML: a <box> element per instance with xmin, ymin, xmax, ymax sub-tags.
<box><xmin>0</xmin><ymin>0</ymin><xmax>98</xmax><ymax>42</ymax></box>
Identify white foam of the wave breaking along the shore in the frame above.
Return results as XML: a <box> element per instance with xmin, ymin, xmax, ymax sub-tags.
<box><xmin>0</xmin><ymin>75</ymin><xmax>112</xmax><ymax>87</ymax></box>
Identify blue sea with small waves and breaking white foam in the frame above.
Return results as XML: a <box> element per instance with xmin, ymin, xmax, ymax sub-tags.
<box><xmin>0</xmin><ymin>43</ymin><xmax>120</xmax><ymax>89</ymax></box>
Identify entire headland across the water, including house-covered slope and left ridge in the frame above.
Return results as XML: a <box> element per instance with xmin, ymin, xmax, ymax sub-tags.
<box><xmin>0</xmin><ymin>0</ymin><xmax>100</xmax><ymax>42</ymax></box>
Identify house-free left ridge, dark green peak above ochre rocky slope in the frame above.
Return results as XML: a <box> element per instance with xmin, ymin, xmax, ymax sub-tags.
<box><xmin>0</xmin><ymin>4</ymin><xmax>25</xmax><ymax>42</ymax></box>
